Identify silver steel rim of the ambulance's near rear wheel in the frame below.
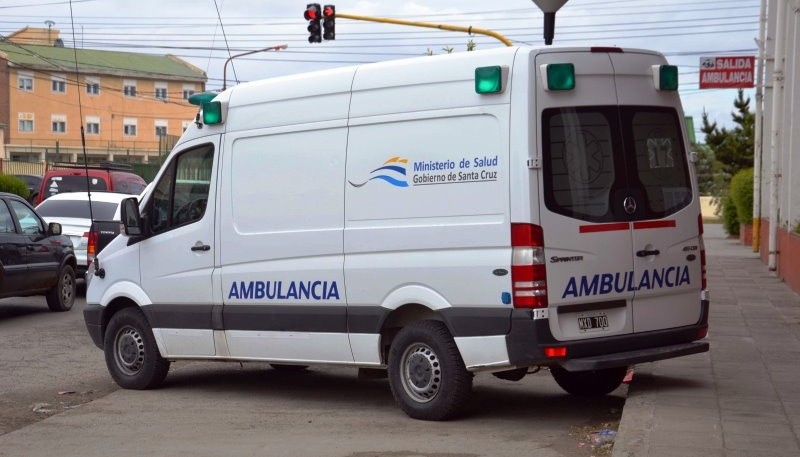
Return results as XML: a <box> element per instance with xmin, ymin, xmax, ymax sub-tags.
<box><xmin>402</xmin><ymin>343</ymin><xmax>442</xmax><ymax>403</ymax></box>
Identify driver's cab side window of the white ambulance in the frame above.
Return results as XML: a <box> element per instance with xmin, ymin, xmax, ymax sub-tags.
<box><xmin>150</xmin><ymin>144</ymin><xmax>214</xmax><ymax>233</ymax></box>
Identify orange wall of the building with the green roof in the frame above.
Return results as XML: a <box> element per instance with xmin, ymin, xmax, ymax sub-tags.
<box><xmin>6</xmin><ymin>69</ymin><xmax>204</xmax><ymax>149</ymax></box>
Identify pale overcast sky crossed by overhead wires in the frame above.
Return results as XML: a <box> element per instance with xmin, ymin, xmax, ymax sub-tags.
<box><xmin>0</xmin><ymin>0</ymin><xmax>760</xmax><ymax>141</ymax></box>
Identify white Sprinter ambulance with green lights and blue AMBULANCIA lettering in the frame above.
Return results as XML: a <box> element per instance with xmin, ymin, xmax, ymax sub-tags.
<box><xmin>85</xmin><ymin>47</ymin><xmax>709</xmax><ymax>420</ymax></box>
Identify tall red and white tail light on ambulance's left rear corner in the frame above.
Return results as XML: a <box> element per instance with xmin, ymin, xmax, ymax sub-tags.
<box><xmin>511</xmin><ymin>224</ymin><xmax>547</xmax><ymax>308</ymax></box>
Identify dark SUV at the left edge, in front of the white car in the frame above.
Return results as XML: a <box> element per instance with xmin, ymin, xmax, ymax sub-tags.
<box><xmin>0</xmin><ymin>192</ymin><xmax>76</xmax><ymax>311</ymax></box>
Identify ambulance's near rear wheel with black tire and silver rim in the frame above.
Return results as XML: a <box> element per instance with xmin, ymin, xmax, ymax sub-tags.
<box><xmin>389</xmin><ymin>321</ymin><xmax>472</xmax><ymax>421</ymax></box>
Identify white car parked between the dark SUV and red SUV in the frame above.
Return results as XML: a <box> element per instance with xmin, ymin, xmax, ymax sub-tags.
<box><xmin>36</xmin><ymin>192</ymin><xmax>131</xmax><ymax>278</ymax></box>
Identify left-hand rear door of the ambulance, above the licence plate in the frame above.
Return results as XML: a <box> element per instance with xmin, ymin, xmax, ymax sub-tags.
<box><xmin>530</xmin><ymin>49</ymin><xmax>634</xmax><ymax>341</ymax></box>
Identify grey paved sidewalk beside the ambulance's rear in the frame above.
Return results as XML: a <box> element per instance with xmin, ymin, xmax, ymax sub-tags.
<box><xmin>613</xmin><ymin>224</ymin><xmax>800</xmax><ymax>457</ymax></box>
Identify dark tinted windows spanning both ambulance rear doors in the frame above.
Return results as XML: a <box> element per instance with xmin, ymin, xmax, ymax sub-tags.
<box><xmin>542</xmin><ymin>106</ymin><xmax>692</xmax><ymax>222</ymax></box>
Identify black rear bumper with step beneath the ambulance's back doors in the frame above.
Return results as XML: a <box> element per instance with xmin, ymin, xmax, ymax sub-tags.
<box><xmin>506</xmin><ymin>300</ymin><xmax>709</xmax><ymax>371</ymax></box>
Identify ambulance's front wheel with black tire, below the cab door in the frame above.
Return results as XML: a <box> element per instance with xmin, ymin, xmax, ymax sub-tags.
<box><xmin>103</xmin><ymin>308</ymin><xmax>169</xmax><ymax>390</ymax></box>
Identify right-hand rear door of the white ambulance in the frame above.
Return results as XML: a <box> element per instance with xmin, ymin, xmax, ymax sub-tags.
<box><xmin>609</xmin><ymin>51</ymin><xmax>702</xmax><ymax>333</ymax></box>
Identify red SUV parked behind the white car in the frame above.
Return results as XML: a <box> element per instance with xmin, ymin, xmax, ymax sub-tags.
<box><xmin>36</xmin><ymin>163</ymin><xmax>147</xmax><ymax>205</ymax></box>
